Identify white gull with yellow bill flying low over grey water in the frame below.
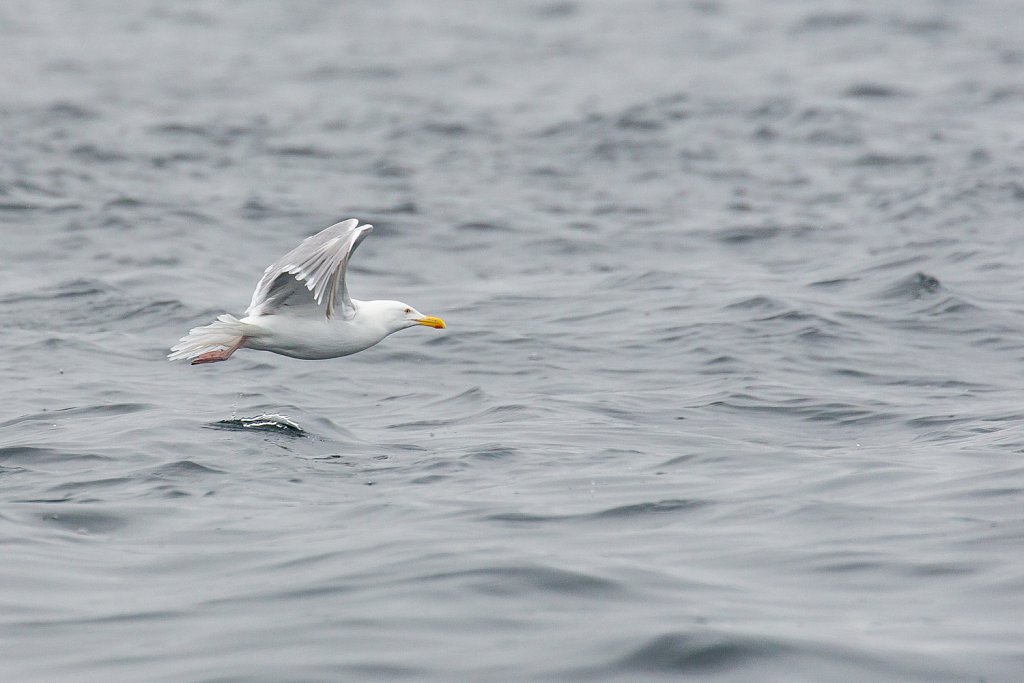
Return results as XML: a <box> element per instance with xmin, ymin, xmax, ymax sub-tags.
<box><xmin>167</xmin><ymin>218</ymin><xmax>444</xmax><ymax>366</ymax></box>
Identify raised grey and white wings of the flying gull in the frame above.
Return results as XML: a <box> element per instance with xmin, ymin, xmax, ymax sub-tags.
<box><xmin>246</xmin><ymin>218</ymin><xmax>373</xmax><ymax>319</ymax></box>
